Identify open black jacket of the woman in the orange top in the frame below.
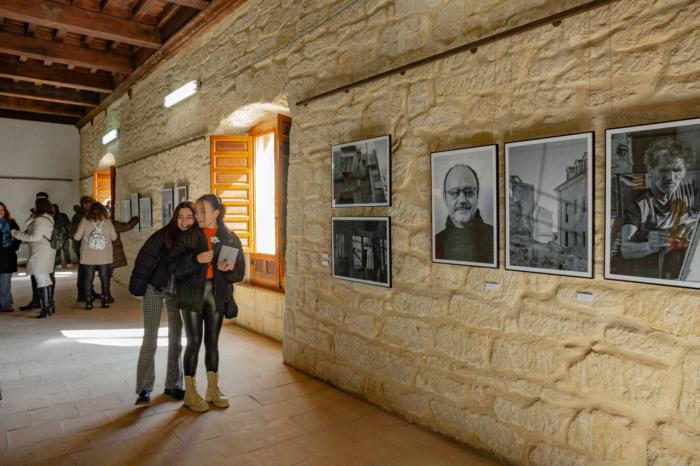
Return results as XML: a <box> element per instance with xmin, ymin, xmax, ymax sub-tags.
<box><xmin>168</xmin><ymin>227</ymin><xmax>245</xmax><ymax>317</ymax></box>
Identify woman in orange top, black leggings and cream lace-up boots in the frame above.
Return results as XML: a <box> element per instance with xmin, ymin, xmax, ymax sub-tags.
<box><xmin>168</xmin><ymin>194</ymin><xmax>245</xmax><ymax>412</ymax></box>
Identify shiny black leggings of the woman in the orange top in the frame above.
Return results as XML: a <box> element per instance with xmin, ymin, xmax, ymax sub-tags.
<box><xmin>180</xmin><ymin>280</ymin><xmax>224</xmax><ymax>377</ymax></box>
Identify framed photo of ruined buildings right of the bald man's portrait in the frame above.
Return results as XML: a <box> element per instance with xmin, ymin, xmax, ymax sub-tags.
<box><xmin>506</xmin><ymin>132</ymin><xmax>594</xmax><ymax>278</ymax></box>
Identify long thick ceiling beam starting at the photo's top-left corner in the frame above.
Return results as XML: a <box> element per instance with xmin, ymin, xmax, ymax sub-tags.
<box><xmin>0</xmin><ymin>0</ymin><xmax>161</xmax><ymax>49</ymax></box>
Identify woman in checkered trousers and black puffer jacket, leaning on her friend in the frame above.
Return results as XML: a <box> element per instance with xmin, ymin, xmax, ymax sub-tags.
<box><xmin>129</xmin><ymin>202</ymin><xmax>194</xmax><ymax>405</ymax></box>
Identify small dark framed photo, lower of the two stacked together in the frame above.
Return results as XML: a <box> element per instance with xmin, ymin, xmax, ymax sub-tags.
<box><xmin>331</xmin><ymin>217</ymin><xmax>391</xmax><ymax>288</ymax></box>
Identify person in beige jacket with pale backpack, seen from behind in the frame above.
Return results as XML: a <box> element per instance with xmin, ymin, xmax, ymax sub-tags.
<box><xmin>73</xmin><ymin>202</ymin><xmax>117</xmax><ymax>310</ymax></box>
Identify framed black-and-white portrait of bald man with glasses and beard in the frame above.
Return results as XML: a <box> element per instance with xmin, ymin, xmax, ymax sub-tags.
<box><xmin>430</xmin><ymin>145</ymin><xmax>498</xmax><ymax>268</ymax></box>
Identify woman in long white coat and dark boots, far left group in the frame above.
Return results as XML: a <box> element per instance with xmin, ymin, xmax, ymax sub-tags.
<box><xmin>10</xmin><ymin>198</ymin><xmax>56</xmax><ymax>319</ymax></box>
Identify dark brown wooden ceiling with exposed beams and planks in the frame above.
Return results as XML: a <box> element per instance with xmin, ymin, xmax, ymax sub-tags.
<box><xmin>0</xmin><ymin>0</ymin><xmax>210</xmax><ymax>124</ymax></box>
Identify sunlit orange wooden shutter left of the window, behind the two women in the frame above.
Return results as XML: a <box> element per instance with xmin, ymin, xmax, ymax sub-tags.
<box><xmin>210</xmin><ymin>136</ymin><xmax>254</xmax><ymax>252</ymax></box>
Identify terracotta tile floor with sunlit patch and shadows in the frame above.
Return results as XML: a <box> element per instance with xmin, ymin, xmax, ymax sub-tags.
<box><xmin>0</xmin><ymin>277</ymin><xmax>504</xmax><ymax>466</ymax></box>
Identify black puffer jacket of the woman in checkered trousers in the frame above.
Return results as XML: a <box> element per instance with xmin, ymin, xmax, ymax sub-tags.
<box><xmin>129</xmin><ymin>225</ymin><xmax>170</xmax><ymax>296</ymax></box>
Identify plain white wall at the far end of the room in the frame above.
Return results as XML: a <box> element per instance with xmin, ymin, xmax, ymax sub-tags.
<box><xmin>0</xmin><ymin>118</ymin><xmax>80</xmax><ymax>260</ymax></box>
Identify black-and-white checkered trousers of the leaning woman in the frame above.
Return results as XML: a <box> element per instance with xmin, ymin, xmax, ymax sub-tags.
<box><xmin>136</xmin><ymin>285</ymin><xmax>184</xmax><ymax>393</ymax></box>
